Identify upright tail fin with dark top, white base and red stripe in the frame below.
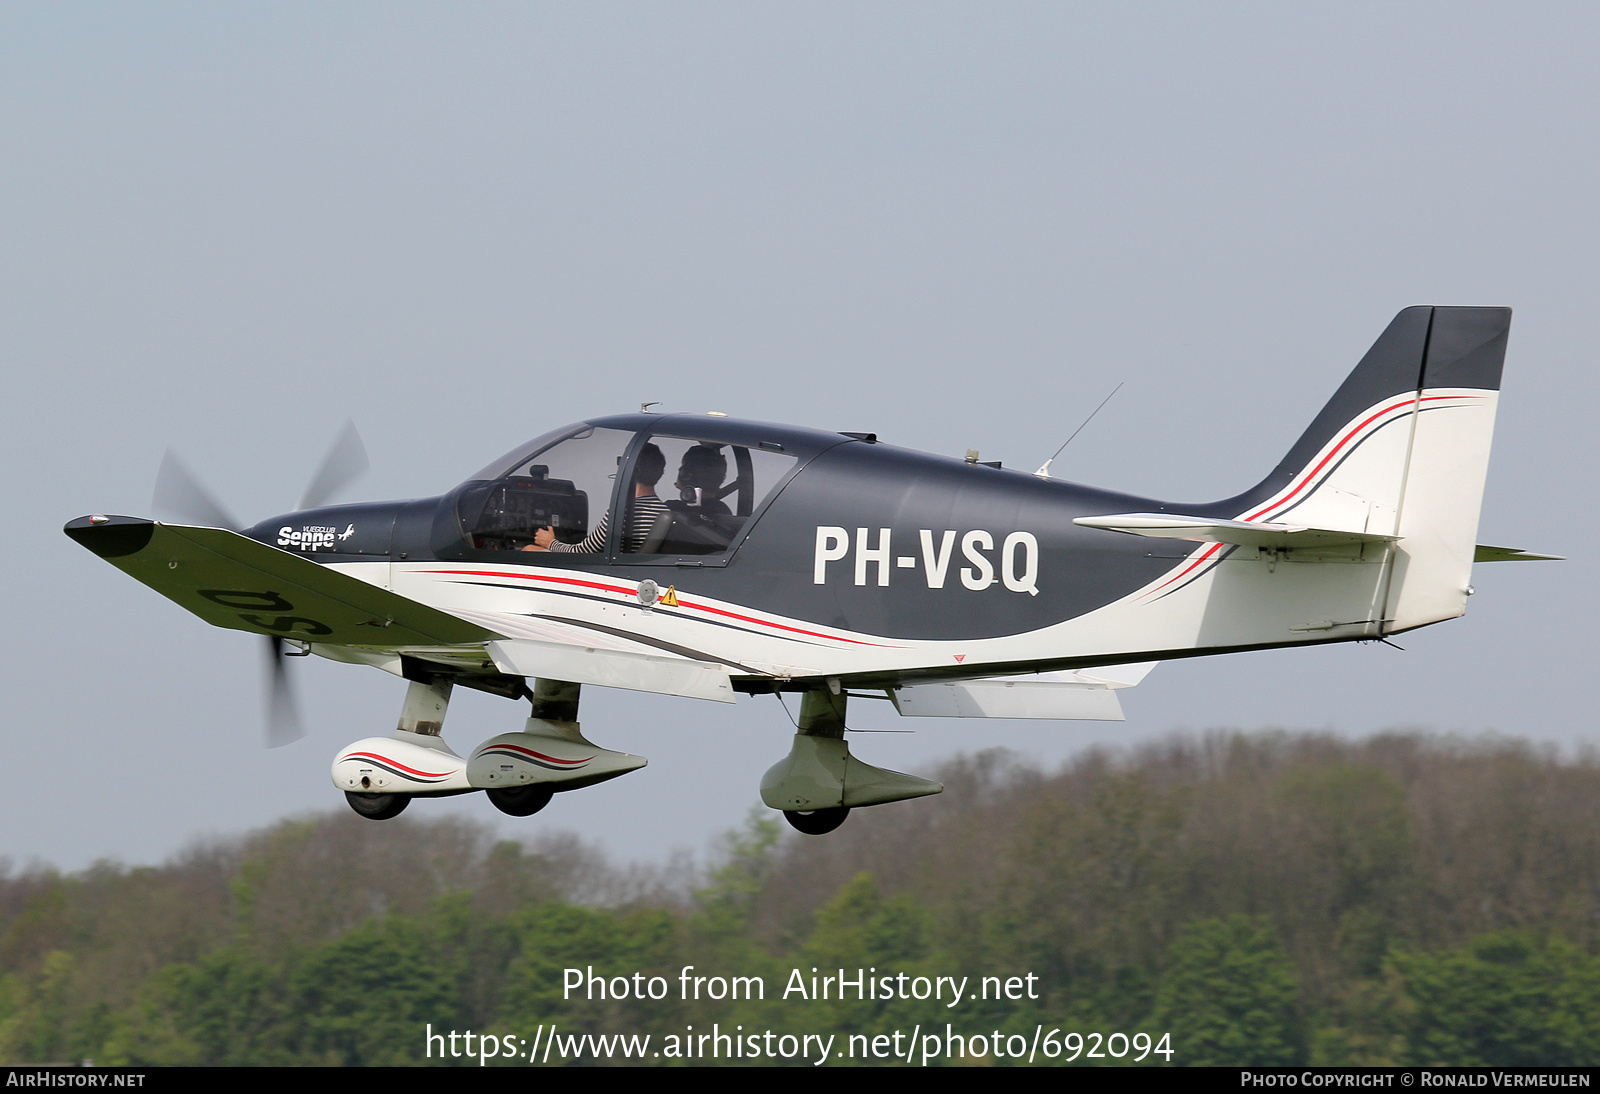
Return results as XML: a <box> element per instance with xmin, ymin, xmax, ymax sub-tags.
<box><xmin>1213</xmin><ymin>307</ymin><xmax>1510</xmax><ymax>633</ymax></box>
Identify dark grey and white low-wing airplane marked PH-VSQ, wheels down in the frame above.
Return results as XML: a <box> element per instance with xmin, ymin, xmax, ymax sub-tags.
<box><xmin>64</xmin><ymin>307</ymin><xmax>1554</xmax><ymax>835</ymax></box>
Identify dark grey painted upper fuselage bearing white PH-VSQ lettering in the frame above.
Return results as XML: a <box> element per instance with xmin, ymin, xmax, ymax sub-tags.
<box><xmin>246</xmin><ymin>307</ymin><xmax>1510</xmax><ymax>653</ymax></box>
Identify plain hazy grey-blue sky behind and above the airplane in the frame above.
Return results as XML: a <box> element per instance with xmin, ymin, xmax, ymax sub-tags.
<box><xmin>0</xmin><ymin>3</ymin><xmax>1600</xmax><ymax>868</ymax></box>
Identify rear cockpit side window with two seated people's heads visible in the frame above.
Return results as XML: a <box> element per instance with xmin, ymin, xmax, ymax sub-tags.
<box><xmin>624</xmin><ymin>435</ymin><xmax>795</xmax><ymax>555</ymax></box>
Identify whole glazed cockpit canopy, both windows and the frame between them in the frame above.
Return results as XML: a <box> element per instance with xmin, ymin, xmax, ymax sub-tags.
<box><xmin>454</xmin><ymin>416</ymin><xmax>798</xmax><ymax>558</ymax></box>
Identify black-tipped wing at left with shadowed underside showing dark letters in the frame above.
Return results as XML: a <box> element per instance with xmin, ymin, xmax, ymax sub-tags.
<box><xmin>66</xmin><ymin>517</ymin><xmax>499</xmax><ymax>648</ymax></box>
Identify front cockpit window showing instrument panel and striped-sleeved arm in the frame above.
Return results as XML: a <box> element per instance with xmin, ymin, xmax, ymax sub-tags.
<box><xmin>458</xmin><ymin>425</ymin><xmax>634</xmax><ymax>553</ymax></box>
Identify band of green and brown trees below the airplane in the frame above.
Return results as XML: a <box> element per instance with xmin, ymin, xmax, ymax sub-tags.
<box><xmin>0</xmin><ymin>734</ymin><xmax>1600</xmax><ymax>1065</ymax></box>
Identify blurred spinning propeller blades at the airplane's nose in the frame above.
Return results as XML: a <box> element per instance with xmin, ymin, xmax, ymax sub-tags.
<box><xmin>150</xmin><ymin>421</ymin><xmax>370</xmax><ymax>749</ymax></box>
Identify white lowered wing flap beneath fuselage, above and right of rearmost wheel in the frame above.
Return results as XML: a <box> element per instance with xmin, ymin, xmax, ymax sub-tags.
<box><xmin>890</xmin><ymin>661</ymin><xmax>1155</xmax><ymax>721</ymax></box>
